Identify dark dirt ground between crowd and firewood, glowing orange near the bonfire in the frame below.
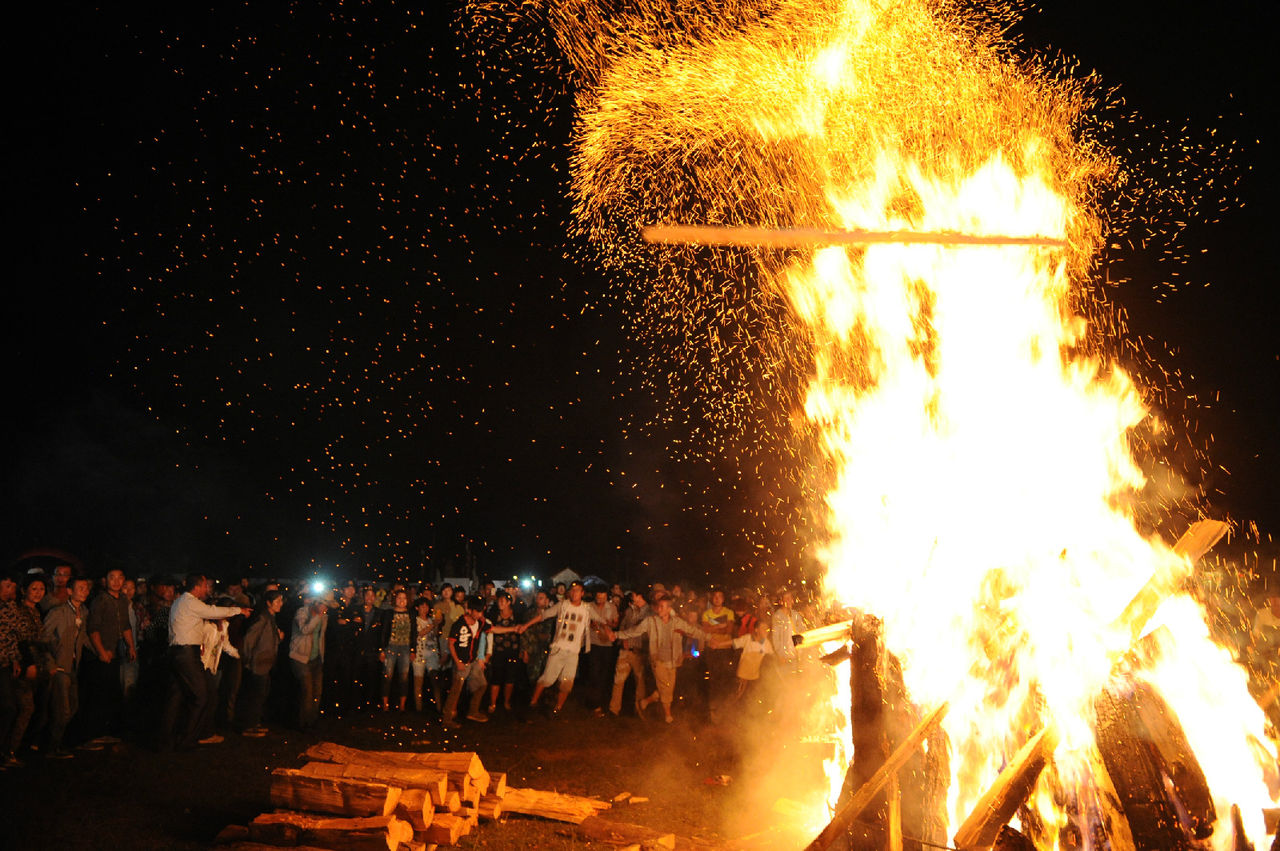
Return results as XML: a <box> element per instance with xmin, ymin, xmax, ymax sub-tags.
<box><xmin>0</xmin><ymin>680</ymin><xmax>820</xmax><ymax>851</ymax></box>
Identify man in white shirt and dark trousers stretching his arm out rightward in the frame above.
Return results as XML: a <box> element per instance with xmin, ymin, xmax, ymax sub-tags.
<box><xmin>160</xmin><ymin>573</ymin><xmax>252</xmax><ymax>750</ymax></box>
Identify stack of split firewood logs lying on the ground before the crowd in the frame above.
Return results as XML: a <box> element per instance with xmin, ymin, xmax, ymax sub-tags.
<box><xmin>213</xmin><ymin>742</ymin><xmax>611</xmax><ymax>851</ymax></box>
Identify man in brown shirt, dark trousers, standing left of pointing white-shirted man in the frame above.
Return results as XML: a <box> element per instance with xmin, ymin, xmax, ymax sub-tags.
<box><xmin>84</xmin><ymin>567</ymin><xmax>138</xmax><ymax>742</ymax></box>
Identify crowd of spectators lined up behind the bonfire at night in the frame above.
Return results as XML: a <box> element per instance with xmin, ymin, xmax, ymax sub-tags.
<box><xmin>0</xmin><ymin>564</ymin><xmax>1280</xmax><ymax>770</ymax></box>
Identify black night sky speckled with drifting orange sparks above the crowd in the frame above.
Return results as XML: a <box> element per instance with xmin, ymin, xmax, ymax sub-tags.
<box><xmin>3</xmin><ymin>3</ymin><xmax>1280</xmax><ymax>577</ymax></box>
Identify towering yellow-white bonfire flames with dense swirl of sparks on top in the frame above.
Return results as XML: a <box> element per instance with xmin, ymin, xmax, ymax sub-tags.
<box><xmin>514</xmin><ymin>0</ymin><xmax>1275</xmax><ymax>846</ymax></box>
